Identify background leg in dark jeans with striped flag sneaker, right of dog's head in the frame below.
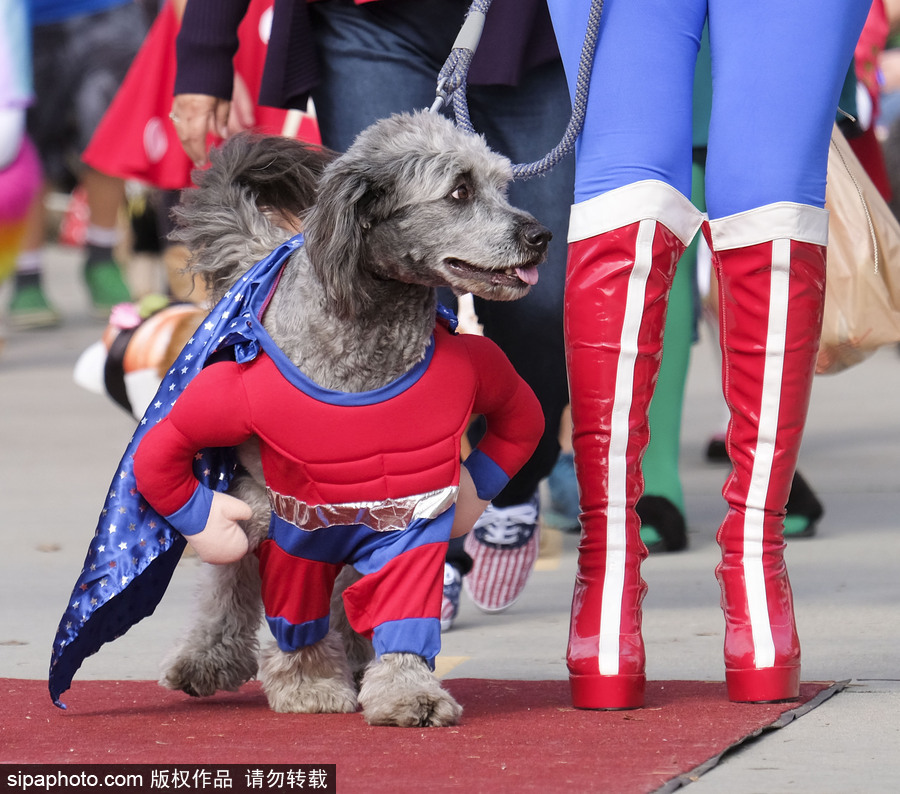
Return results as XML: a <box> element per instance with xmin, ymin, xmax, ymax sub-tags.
<box><xmin>463</xmin><ymin>61</ymin><xmax>575</xmax><ymax>612</ymax></box>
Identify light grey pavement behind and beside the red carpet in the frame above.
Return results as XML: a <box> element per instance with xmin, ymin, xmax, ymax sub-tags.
<box><xmin>0</xmin><ymin>248</ymin><xmax>900</xmax><ymax>794</ymax></box>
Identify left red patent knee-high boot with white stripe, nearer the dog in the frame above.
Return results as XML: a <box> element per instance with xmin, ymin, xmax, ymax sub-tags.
<box><xmin>565</xmin><ymin>181</ymin><xmax>702</xmax><ymax>708</ymax></box>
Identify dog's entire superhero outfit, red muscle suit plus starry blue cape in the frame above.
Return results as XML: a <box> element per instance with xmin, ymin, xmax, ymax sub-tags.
<box><xmin>50</xmin><ymin>230</ymin><xmax>542</xmax><ymax>703</ymax></box>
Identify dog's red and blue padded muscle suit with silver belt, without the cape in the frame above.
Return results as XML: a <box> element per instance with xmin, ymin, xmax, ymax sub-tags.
<box><xmin>135</xmin><ymin>294</ymin><xmax>540</xmax><ymax>662</ymax></box>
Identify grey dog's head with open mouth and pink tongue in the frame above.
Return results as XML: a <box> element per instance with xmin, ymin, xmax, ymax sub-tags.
<box><xmin>306</xmin><ymin>112</ymin><xmax>550</xmax><ymax>316</ymax></box>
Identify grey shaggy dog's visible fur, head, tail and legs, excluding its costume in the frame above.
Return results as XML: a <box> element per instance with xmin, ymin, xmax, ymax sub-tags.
<box><xmin>136</xmin><ymin>112</ymin><xmax>550</xmax><ymax>726</ymax></box>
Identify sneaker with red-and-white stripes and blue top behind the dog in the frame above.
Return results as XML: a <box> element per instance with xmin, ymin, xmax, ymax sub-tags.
<box><xmin>463</xmin><ymin>494</ymin><xmax>540</xmax><ymax>613</ymax></box>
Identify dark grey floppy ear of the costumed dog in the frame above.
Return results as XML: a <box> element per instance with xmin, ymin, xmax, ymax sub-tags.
<box><xmin>304</xmin><ymin>157</ymin><xmax>386</xmax><ymax>319</ymax></box>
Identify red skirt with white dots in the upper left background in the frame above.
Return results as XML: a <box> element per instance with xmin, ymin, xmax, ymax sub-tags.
<box><xmin>82</xmin><ymin>0</ymin><xmax>321</xmax><ymax>190</ymax></box>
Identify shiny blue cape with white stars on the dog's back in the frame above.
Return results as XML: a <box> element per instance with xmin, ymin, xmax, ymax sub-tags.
<box><xmin>49</xmin><ymin>235</ymin><xmax>303</xmax><ymax>708</ymax></box>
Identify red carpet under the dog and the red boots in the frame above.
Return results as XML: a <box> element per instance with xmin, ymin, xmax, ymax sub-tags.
<box><xmin>0</xmin><ymin>678</ymin><xmax>843</xmax><ymax>794</ymax></box>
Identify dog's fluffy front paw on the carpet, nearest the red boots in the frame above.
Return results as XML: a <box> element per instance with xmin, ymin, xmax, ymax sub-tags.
<box><xmin>359</xmin><ymin>653</ymin><xmax>462</xmax><ymax>728</ymax></box>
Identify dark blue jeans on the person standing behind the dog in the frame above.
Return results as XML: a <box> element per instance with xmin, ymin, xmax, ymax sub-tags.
<box><xmin>309</xmin><ymin>0</ymin><xmax>574</xmax><ymax>507</ymax></box>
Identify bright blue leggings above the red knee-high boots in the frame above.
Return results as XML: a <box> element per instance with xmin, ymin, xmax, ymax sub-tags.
<box><xmin>548</xmin><ymin>0</ymin><xmax>870</xmax><ymax>218</ymax></box>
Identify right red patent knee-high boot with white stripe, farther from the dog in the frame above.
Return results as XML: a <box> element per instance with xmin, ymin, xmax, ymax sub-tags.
<box><xmin>704</xmin><ymin>202</ymin><xmax>828</xmax><ymax>702</ymax></box>
